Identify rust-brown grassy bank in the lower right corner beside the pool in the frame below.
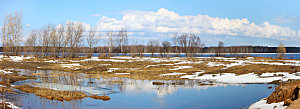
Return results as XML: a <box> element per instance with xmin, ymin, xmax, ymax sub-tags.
<box><xmin>267</xmin><ymin>80</ymin><xmax>300</xmax><ymax>109</ymax></box>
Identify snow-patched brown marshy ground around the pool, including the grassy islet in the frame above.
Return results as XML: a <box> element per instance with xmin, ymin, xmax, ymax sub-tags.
<box><xmin>0</xmin><ymin>56</ymin><xmax>300</xmax><ymax>108</ymax></box>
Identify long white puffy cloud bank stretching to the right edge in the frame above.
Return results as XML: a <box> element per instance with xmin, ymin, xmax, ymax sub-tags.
<box><xmin>97</xmin><ymin>8</ymin><xmax>299</xmax><ymax>40</ymax></box>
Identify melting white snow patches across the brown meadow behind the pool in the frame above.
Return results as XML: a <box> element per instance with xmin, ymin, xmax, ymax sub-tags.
<box><xmin>0</xmin><ymin>56</ymin><xmax>300</xmax><ymax>84</ymax></box>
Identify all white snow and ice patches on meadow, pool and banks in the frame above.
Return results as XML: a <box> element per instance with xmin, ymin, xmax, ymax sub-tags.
<box><xmin>0</xmin><ymin>55</ymin><xmax>300</xmax><ymax>109</ymax></box>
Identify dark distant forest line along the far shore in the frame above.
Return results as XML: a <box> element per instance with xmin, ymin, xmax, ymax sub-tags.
<box><xmin>0</xmin><ymin>45</ymin><xmax>300</xmax><ymax>53</ymax></box>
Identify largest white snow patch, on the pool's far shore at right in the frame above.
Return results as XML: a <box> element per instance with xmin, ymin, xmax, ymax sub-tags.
<box><xmin>180</xmin><ymin>72</ymin><xmax>300</xmax><ymax>84</ymax></box>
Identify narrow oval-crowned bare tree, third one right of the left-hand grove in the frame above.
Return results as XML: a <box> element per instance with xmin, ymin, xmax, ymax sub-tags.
<box><xmin>117</xmin><ymin>28</ymin><xmax>128</xmax><ymax>54</ymax></box>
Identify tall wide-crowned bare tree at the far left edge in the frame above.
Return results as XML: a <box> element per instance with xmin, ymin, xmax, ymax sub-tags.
<box><xmin>2</xmin><ymin>12</ymin><xmax>23</xmax><ymax>55</ymax></box>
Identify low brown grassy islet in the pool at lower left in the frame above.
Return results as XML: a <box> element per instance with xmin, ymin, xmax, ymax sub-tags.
<box><xmin>14</xmin><ymin>85</ymin><xmax>110</xmax><ymax>101</ymax></box>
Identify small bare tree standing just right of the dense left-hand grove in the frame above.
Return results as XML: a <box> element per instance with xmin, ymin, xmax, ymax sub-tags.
<box><xmin>86</xmin><ymin>28</ymin><xmax>100</xmax><ymax>57</ymax></box>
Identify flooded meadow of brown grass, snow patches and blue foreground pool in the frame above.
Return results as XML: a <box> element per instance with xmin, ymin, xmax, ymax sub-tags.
<box><xmin>0</xmin><ymin>56</ymin><xmax>300</xmax><ymax>109</ymax></box>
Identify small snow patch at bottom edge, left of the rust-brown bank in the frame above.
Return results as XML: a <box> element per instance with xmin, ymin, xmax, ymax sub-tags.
<box><xmin>248</xmin><ymin>98</ymin><xmax>287</xmax><ymax>109</ymax></box>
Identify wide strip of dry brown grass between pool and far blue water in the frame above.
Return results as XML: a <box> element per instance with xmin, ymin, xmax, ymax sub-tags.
<box><xmin>4</xmin><ymin>57</ymin><xmax>300</xmax><ymax>80</ymax></box>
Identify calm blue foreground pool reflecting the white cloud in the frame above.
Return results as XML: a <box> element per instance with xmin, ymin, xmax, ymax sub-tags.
<box><xmin>4</xmin><ymin>69</ymin><xmax>274</xmax><ymax>109</ymax></box>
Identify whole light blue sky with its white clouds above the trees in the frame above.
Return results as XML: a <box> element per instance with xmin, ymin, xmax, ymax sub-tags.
<box><xmin>0</xmin><ymin>0</ymin><xmax>300</xmax><ymax>46</ymax></box>
